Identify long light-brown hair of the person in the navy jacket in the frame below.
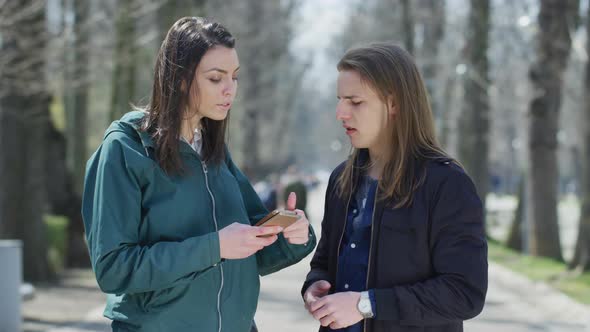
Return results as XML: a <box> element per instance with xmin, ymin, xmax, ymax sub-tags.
<box><xmin>337</xmin><ymin>43</ymin><xmax>455</xmax><ymax>207</ymax></box>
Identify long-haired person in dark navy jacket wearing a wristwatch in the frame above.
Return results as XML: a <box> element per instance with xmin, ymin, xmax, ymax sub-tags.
<box><xmin>302</xmin><ymin>43</ymin><xmax>487</xmax><ymax>332</ymax></box>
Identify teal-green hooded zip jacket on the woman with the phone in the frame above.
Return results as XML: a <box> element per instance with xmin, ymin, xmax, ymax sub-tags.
<box><xmin>82</xmin><ymin>111</ymin><xmax>316</xmax><ymax>332</ymax></box>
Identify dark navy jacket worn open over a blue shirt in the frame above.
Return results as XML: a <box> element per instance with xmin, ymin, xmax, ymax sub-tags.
<box><xmin>302</xmin><ymin>153</ymin><xmax>488</xmax><ymax>332</ymax></box>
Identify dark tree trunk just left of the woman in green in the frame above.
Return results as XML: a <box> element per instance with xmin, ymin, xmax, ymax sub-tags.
<box><xmin>58</xmin><ymin>1</ymin><xmax>90</xmax><ymax>267</ymax></box>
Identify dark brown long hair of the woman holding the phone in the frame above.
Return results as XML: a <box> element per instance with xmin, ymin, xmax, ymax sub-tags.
<box><xmin>141</xmin><ymin>17</ymin><xmax>235</xmax><ymax>174</ymax></box>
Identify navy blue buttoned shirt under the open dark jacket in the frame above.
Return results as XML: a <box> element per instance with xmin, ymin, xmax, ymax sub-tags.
<box><xmin>336</xmin><ymin>175</ymin><xmax>378</xmax><ymax>332</ymax></box>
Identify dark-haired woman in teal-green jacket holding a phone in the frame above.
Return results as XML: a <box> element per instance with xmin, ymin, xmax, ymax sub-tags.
<box><xmin>82</xmin><ymin>17</ymin><xmax>315</xmax><ymax>332</ymax></box>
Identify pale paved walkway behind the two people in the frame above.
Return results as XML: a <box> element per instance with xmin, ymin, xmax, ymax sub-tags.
<box><xmin>20</xmin><ymin>183</ymin><xmax>590</xmax><ymax>332</ymax></box>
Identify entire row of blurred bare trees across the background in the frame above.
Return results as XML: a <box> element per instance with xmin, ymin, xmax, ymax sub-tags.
<box><xmin>0</xmin><ymin>0</ymin><xmax>590</xmax><ymax>281</ymax></box>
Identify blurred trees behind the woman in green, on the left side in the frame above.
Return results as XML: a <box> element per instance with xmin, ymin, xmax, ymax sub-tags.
<box><xmin>0</xmin><ymin>0</ymin><xmax>307</xmax><ymax>281</ymax></box>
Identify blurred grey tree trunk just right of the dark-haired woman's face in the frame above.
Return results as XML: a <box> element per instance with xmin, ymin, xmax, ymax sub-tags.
<box><xmin>238</xmin><ymin>1</ymin><xmax>295</xmax><ymax>180</ymax></box>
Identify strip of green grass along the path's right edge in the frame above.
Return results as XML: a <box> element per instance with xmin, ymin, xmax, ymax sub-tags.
<box><xmin>488</xmin><ymin>240</ymin><xmax>590</xmax><ymax>305</ymax></box>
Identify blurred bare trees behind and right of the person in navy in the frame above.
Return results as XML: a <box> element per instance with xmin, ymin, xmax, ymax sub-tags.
<box><xmin>335</xmin><ymin>0</ymin><xmax>590</xmax><ymax>270</ymax></box>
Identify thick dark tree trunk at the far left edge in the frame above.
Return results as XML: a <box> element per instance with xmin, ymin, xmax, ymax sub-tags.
<box><xmin>0</xmin><ymin>0</ymin><xmax>54</xmax><ymax>282</ymax></box>
